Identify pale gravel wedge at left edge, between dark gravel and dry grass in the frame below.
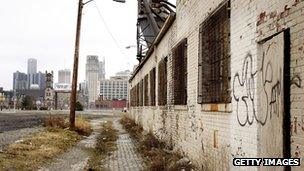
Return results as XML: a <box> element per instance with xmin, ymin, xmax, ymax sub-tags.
<box><xmin>0</xmin><ymin>127</ymin><xmax>43</xmax><ymax>151</ymax></box>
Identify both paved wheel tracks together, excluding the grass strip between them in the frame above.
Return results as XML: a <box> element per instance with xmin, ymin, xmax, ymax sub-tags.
<box><xmin>40</xmin><ymin>117</ymin><xmax>144</xmax><ymax>171</ymax></box>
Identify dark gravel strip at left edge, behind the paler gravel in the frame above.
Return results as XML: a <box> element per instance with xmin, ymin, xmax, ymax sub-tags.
<box><xmin>0</xmin><ymin>113</ymin><xmax>46</xmax><ymax>133</ymax></box>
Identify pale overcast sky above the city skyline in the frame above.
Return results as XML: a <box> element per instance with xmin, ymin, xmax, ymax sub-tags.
<box><xmin>0</xmin><ymin>0</ymin><xmax>141</xmax><ymax>90</ymax></box>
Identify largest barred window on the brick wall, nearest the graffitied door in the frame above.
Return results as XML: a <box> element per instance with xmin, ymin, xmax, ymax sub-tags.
<box><xmin>198</xmin><ymin>2</ymin><xmax>231</xmax><ymax>103</ymax></box>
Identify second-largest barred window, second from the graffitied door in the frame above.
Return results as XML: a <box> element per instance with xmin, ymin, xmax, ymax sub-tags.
<box><xmin>172</xmin><ymin>39</ymin><xmax>187</xmax><ymax>105</ymax></box>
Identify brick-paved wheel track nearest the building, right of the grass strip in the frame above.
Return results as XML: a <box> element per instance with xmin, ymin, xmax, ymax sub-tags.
<box><xmin>104</xmin><ymin>120</ymin><xmax>144</xmax><ymax>171</ymax></box>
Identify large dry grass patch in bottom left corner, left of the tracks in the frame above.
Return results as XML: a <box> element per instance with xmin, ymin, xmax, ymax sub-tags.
<box><xmin>0</xmin><ymin>128</ymin><xmax>81</xmax><ymax>170</ymax></box>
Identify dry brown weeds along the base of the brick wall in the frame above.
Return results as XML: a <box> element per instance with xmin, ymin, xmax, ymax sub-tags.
<box><xmin>120</xmin><ymin>116</ymin><xmax>193</xmax><ymax>171</ymax></box>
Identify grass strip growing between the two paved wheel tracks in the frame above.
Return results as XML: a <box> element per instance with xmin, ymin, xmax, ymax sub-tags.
<box><xmin>86</xmin><ymin>122</ymin><xmax>118</xmax><ymax>170</ymax></box>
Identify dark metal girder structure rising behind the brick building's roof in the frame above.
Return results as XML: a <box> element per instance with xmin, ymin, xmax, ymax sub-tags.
<box><xmin>137</xmin><ymin>0</ymin><xmax>176</xmax><ymax>61</ymax></box>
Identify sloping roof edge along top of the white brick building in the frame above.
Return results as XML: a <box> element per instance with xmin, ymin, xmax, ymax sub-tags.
<box><xmin>129</xmin><ymin>12</ymin><xmax>176</xmax><ymax>82</ymax></box>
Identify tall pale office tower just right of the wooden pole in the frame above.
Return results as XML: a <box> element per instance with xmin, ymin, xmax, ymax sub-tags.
<box><xmin>86</xmin><ymin>55</ymin><xmax>100</xmax><ymax>107</ymax></box>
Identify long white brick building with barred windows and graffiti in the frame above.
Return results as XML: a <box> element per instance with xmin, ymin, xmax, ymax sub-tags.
<box><xmin>129</xmin><ymin>0</ymin><xmax>304</xmax><ymax>170</ymax></box>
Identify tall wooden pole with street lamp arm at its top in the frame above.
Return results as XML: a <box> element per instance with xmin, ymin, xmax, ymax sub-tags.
<box><xmin>70</xmin><ymin>0</ymin><xmax>126</xmax><ymax>130</ymax></box>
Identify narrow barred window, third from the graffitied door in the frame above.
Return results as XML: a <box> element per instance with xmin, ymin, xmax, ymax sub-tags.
<box><xmin>158</xmin><ymin>58</ymin><xmax>167</xmax><ymax>106</ymax></box>
